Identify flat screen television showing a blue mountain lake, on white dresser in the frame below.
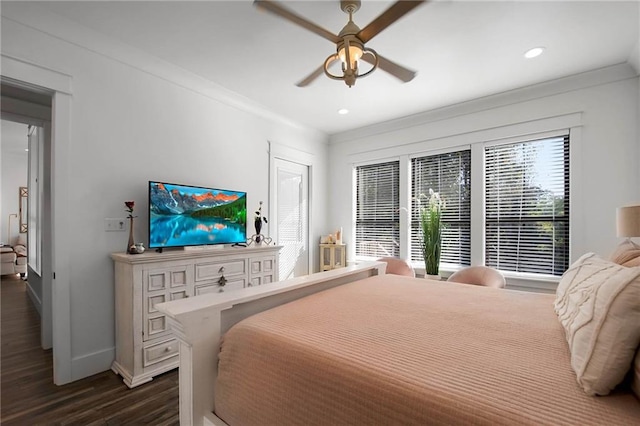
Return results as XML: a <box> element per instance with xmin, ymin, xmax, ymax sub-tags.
<box><xmin>149</xmin><ymin>181</ymin><xmax>247</xmax><ymax>248</ymax></box>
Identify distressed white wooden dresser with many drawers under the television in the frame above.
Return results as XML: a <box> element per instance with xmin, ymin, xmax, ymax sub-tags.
<box><xmin>111</xmin><ymin>246</ymin><xmax>281</xmax><ymax>388</ymax></box>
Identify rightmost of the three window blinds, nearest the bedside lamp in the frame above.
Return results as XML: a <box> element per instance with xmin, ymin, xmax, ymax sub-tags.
<box><xmin>485</xmin><ymin>135</ymin><xmax>569</xmax><ymax>276</ymax></box>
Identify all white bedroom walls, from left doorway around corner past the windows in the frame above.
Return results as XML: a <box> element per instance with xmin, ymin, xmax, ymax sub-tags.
<box><xmin>2</xmin><ymin>4</ymin><xmax>640</xmax><ymax>379</ymax></box>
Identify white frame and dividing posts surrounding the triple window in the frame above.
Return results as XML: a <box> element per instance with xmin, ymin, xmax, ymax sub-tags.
<box><xmin>347</xmin><ymin>125</ymin><xmax>586</xmax><ymax>292</ymax></box>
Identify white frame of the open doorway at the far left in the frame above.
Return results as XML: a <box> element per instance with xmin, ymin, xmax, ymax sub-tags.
<box><xmin>0</xmin><ymin>53</ymin><xmax>73</xmax><ymax>385</ymax></box>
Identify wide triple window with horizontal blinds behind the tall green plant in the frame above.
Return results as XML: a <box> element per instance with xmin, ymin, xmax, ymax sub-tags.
<box><xmin>354</xmin><ymin>130</ymin><xmax>570</xmax><ymax>286</ymax></box>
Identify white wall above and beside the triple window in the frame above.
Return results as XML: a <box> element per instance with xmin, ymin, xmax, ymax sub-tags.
<box><xmin>329</xmin><ymin>64</ymin><xmax>640</xmax><ymax>272</ymax></box>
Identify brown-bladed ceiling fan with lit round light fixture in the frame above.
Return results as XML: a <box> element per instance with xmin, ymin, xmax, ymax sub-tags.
<box><xmin>253</xmin><ymin>0</ymin><xmax>424</xmax><ymax>87</ymax></box>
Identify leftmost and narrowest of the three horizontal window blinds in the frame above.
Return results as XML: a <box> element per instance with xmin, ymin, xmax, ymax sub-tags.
<box><xmin>356</xmin><ymin>161</ymin><xmax>400</xmax><ymax>258</ymax></box>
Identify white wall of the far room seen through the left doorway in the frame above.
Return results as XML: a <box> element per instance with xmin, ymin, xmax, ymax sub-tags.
<box><xmin>0</xmin><ymin>120</ymin><xmax>28</xmax><ymax>244</ymax></box>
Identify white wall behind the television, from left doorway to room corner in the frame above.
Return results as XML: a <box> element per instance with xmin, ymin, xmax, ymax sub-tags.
<box><xmin>2</xmin><ymin>12</ymin><xmax>328</xmax><ymax>379</ymax></box>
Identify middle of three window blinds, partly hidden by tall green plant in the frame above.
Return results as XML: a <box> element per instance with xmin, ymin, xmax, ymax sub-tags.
<box><xmin>411</xmin><ymin>149</ymin><xmax>471</xmax><ymax>266</ymax></box>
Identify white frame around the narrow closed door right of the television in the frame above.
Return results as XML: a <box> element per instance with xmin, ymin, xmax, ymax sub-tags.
<box><xmin>269</xmin><ymin>142</ymin><xmax>318</xmax><ymax>274</ymax></box>
